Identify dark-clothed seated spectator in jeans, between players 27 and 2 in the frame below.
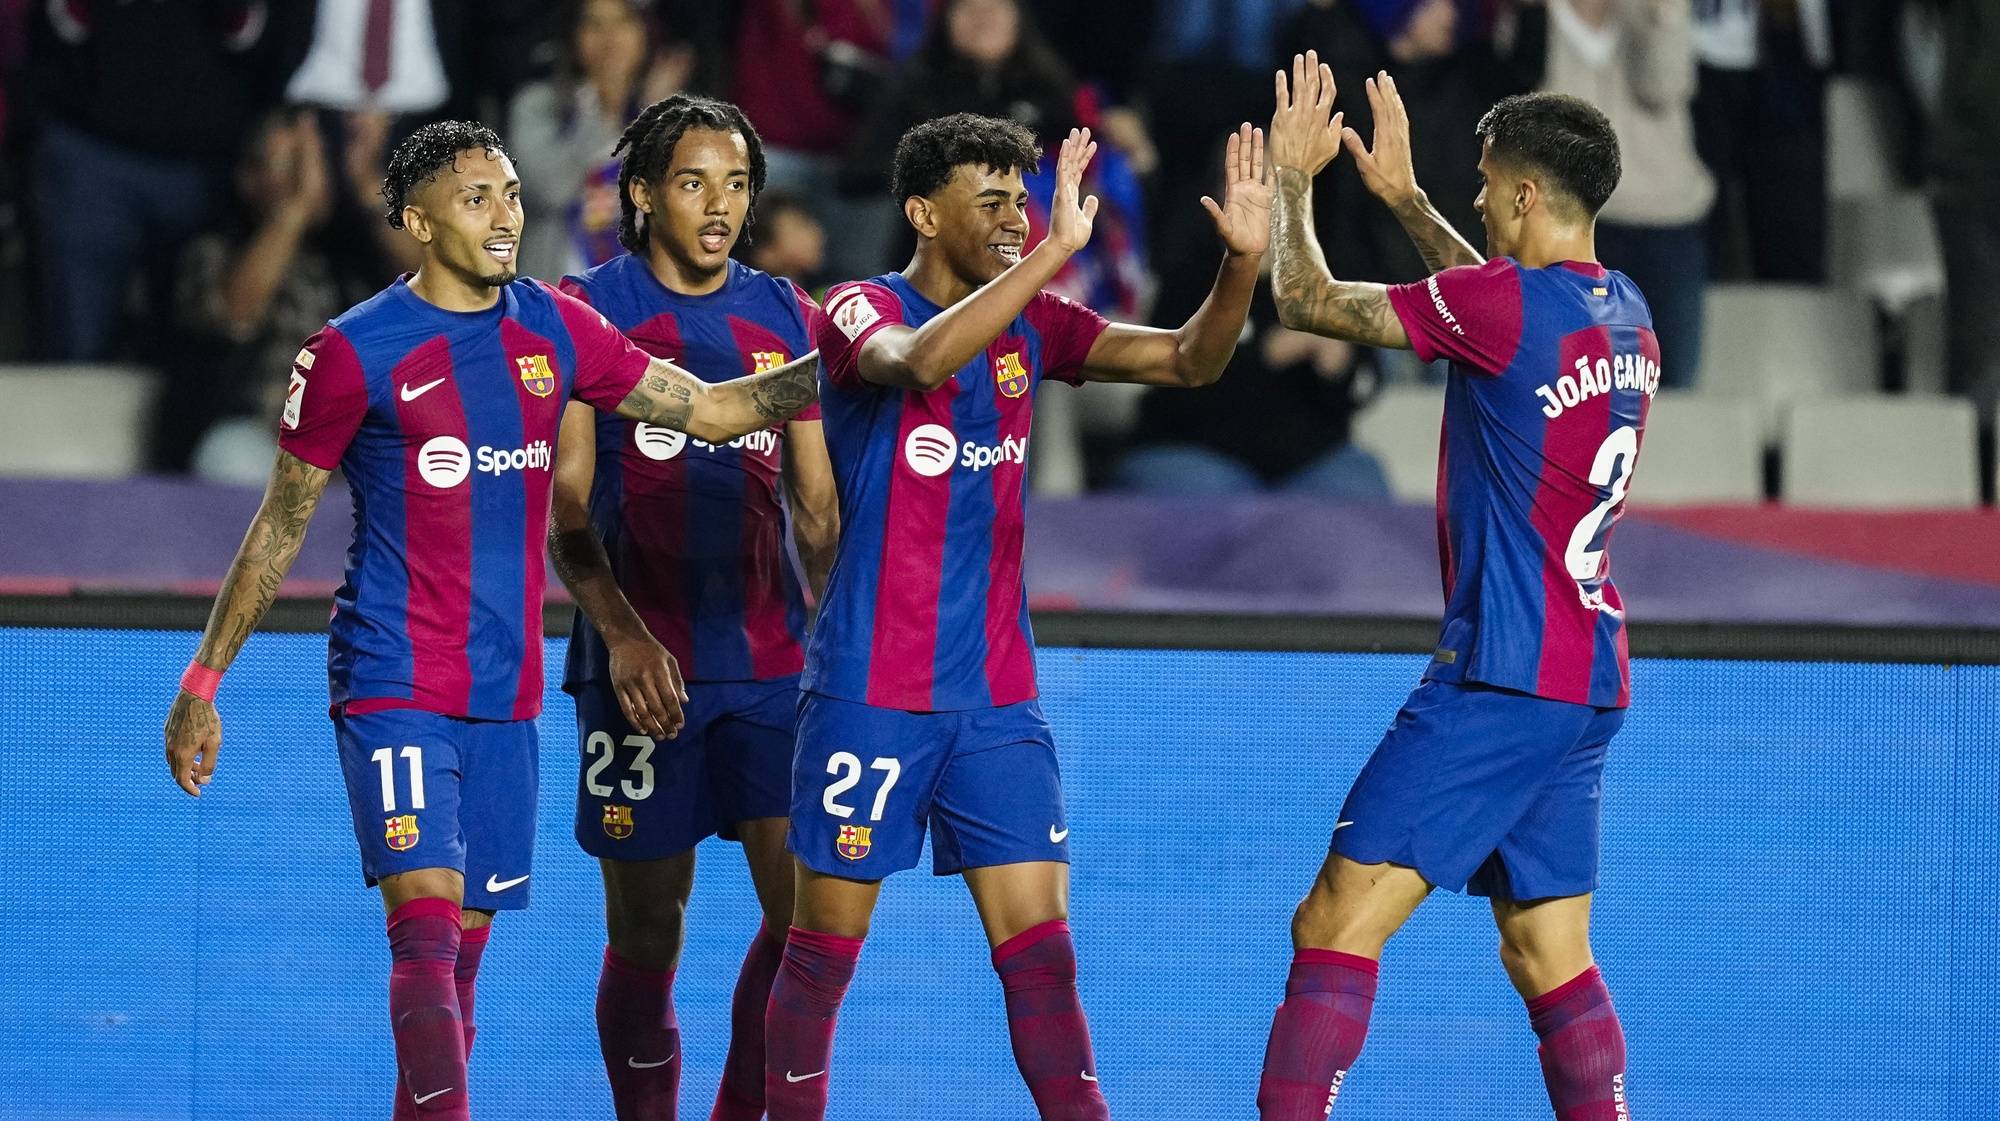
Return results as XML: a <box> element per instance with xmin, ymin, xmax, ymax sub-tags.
<box><xmin>1112</xmin><ymin>278</ymin><xmax>1388</xmax><ymax>502</ymax></box>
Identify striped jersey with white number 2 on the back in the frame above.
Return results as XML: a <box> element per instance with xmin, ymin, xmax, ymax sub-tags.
<box><xmin>1388</xmin><ymin>258</ymin><xmax>1660</xmax><ymax>709</ymax></box>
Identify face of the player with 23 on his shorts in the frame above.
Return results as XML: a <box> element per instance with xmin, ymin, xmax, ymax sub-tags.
<box><xmin>632</xmin><ymin>128</ymin><xmax>750</xmax><ymax>278</ymax></box>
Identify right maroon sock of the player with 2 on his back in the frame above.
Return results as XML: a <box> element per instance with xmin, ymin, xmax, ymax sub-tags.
<box><xmin>1528</xmin><ymin>965</ymin><xmax>1630</xmax><ymax>1121</ymax></box>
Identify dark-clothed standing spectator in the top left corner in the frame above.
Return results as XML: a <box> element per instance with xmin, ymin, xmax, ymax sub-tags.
<box><xmin>28</xmin><ymin>0</ymin><xmax>294</xmax><ymax>360</ymax></box>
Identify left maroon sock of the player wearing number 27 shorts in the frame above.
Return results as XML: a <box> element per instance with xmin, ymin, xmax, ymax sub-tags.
<box><xmin>764</xmin><ymin>927</ymin><xmax>862</xmax><ymax>1121</ymax></box>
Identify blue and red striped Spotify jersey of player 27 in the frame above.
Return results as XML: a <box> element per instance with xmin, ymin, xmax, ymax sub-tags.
<box><xmin>804</xmin><ymin>274</ymin><xmax>1106</xmax><ymax>711</ymax></box>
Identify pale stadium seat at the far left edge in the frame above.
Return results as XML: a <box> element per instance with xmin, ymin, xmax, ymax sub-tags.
<box><xmin>0</xmin><ymin>364</ymin><xmax>158</xmax><ymax>478</ymax></box>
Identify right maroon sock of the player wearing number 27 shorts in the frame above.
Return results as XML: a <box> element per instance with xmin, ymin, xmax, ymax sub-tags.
<box><xmin>994</xmin><ymin>919</ymin><xmax>1112</xmax><ymax>1121</ymax></box>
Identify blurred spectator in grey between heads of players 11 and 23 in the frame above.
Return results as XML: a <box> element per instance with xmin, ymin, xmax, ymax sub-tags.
<box><xmin>506</xmin><ymin>0</ymin><xmax>694</xmax><ymax>284</ymax></box>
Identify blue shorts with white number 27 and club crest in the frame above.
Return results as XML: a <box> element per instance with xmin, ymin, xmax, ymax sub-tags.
<box><xmin>786</xmin><ymin>693</ymin><xmax>1070</xmax><ymax>881</ymax></box>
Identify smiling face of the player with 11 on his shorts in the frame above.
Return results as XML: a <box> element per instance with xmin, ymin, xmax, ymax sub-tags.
<box><xmin>404</xmin><ymin>148</ymin><xmax>522</xmax><ymax>288</ymax></box>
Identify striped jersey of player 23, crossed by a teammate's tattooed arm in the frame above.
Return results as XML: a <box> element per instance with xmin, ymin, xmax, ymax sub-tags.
<box><xmin>562</xmin><ymin>254</ymin><xmax>820</xmax><ymax>691</ymax></box>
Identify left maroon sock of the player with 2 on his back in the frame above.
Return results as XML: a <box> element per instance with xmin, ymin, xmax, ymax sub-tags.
<box><xmin>1256</xmin><ymin>949</ymin><xmax>1380</xmax><ymax>1121</ymax></box>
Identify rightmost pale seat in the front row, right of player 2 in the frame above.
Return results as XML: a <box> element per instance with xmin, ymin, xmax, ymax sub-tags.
<box><xmin>1782</xmin><ymin>396</ymin><xmax>1980</xmax><ymax>508</ymax></box>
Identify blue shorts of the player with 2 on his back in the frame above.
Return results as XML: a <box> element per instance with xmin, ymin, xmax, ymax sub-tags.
<box><xmin>1332</xmin><ymin>681</ymin><xmax>1624</xmax><ymax>901</ymax></box>
